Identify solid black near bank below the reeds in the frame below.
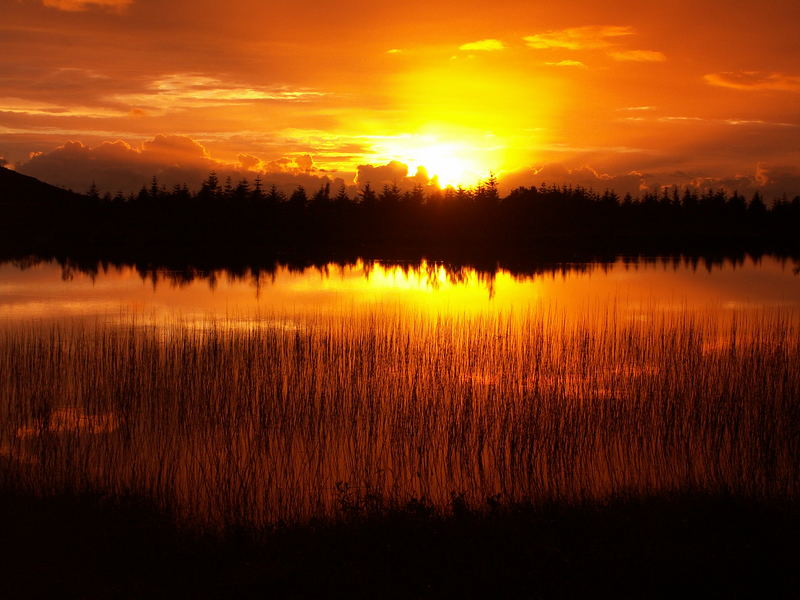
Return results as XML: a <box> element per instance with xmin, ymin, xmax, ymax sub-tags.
<box><xmin>0</xmin><ymin>495</ymin><xmax>800</xmax><ymax>598</ymax></box>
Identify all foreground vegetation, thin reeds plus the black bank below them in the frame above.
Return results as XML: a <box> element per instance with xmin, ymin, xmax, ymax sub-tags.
<box><xmin>0</xmin><ymin>314</ymin><xmax>800</xmax><ymax>598</ymax></box>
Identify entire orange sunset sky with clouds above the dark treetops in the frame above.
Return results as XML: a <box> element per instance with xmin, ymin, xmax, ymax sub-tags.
<box><xmin>0</xmin><ymin>0</ymin><xmax>800</xmax><ymax>195</ymax></box>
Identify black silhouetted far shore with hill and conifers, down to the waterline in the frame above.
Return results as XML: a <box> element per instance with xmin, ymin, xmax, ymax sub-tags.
<box><xmin>0</xmin><ymin>168</ymin><xmax>800</xmax><ymax>263</ymax></box>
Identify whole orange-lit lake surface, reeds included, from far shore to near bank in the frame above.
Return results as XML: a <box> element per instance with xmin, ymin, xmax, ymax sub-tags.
<box><xmin>0</xmin><ymin>259</ymin><xmax>800</xmax><ymax>527</ymax></box>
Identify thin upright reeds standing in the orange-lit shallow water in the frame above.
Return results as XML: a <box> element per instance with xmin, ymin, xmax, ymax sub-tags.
<box><xmin>0</xmin><ymin>308</ymin><xmax>800</xmax><ymax>528</ymax></box>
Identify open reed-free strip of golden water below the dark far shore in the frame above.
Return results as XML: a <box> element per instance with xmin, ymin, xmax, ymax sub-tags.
<box><xmin>0</xmin><ymin>258</ymin><xmax>800</xmax><ymax>327</ymax></box>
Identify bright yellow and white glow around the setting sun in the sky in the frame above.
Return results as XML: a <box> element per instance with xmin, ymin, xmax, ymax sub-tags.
<box><xmin>370</xmin><ymin>57</ymin><xmax>563</xmax><ymax>187</ymax></box>
